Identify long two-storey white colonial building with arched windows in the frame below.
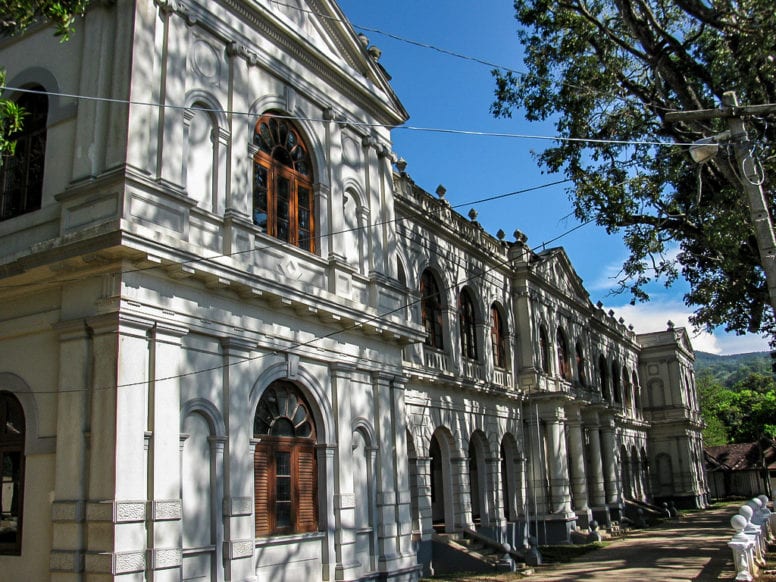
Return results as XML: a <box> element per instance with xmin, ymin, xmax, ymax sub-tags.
<box><xmin>0</xmin><ymin>0</ymin><xmax>707</xmax><ymax>582</ymax></box>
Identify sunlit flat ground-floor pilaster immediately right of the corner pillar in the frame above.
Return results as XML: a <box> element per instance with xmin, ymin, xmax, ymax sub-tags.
<box><xmin>148</xmin><ymin>323</ymin><xmax>188</xmax><ymax>582</ymax></box>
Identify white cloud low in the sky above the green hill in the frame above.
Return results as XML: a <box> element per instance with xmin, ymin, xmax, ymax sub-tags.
<box><xmin>605</xmin><ymin>300</ymin><xmax>769</xmax><ymax>355</ymax></box>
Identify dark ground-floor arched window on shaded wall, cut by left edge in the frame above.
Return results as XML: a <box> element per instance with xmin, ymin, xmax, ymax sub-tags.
<box><xmin>0</xmin><ymin>392</ymin><xmax>25</xmax><ymax>555</ymax></box>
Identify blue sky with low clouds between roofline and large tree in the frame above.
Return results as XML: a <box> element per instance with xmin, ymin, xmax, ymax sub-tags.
<box><xmin>339</xmin><ymin>0</ymin><xmax>768</xmax><ymax>354</ymax></box>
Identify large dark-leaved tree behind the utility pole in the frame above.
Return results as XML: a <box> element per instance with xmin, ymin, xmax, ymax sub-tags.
<box><xmin>492</xmin><ymin>0</ymin><xmax>776</xmax><ymax>338</ymax></box>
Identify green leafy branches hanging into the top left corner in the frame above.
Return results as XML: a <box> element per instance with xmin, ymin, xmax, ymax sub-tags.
<box><xmin>0</xmin><ymin>0</ymin><xmax>91</xmax><ymax>157</ymax></box>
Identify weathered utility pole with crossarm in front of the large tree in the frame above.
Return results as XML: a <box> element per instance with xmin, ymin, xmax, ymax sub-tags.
<box><xmin>665</xmin><ymin>91</ymin><xmax>776</xmax><ymax>322</ymax></box>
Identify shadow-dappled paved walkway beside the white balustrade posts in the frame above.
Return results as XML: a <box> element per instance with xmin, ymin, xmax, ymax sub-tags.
<box><xmin>527</xmin><ymin>505</ymin><xmax>738</xmax><ymax>582</ymax></box>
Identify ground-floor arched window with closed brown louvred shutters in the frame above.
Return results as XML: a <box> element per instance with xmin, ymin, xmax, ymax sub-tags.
<box><xmin>253</xmin><ymin>381</ymin><xmax>318</xmax><ymax>537</ymax></box>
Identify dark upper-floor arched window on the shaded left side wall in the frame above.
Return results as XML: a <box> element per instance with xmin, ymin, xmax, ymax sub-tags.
<box><xmin>0</xmin><ymin>87</ymin><xmax>48</xmax><ymax>220</ymax></box>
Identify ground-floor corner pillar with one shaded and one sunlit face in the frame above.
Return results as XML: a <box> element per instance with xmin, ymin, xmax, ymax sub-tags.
<box><xmin>84</xmin><ymin>314</ymin><xmax>152</xmax><ymax>582</ymax></box>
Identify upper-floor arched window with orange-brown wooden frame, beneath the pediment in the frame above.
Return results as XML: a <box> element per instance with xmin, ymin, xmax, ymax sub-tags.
<box><xmin>253</xmin><ymin>115</ymin><xmax>315</xmax><ymax>252</ymax></box>
